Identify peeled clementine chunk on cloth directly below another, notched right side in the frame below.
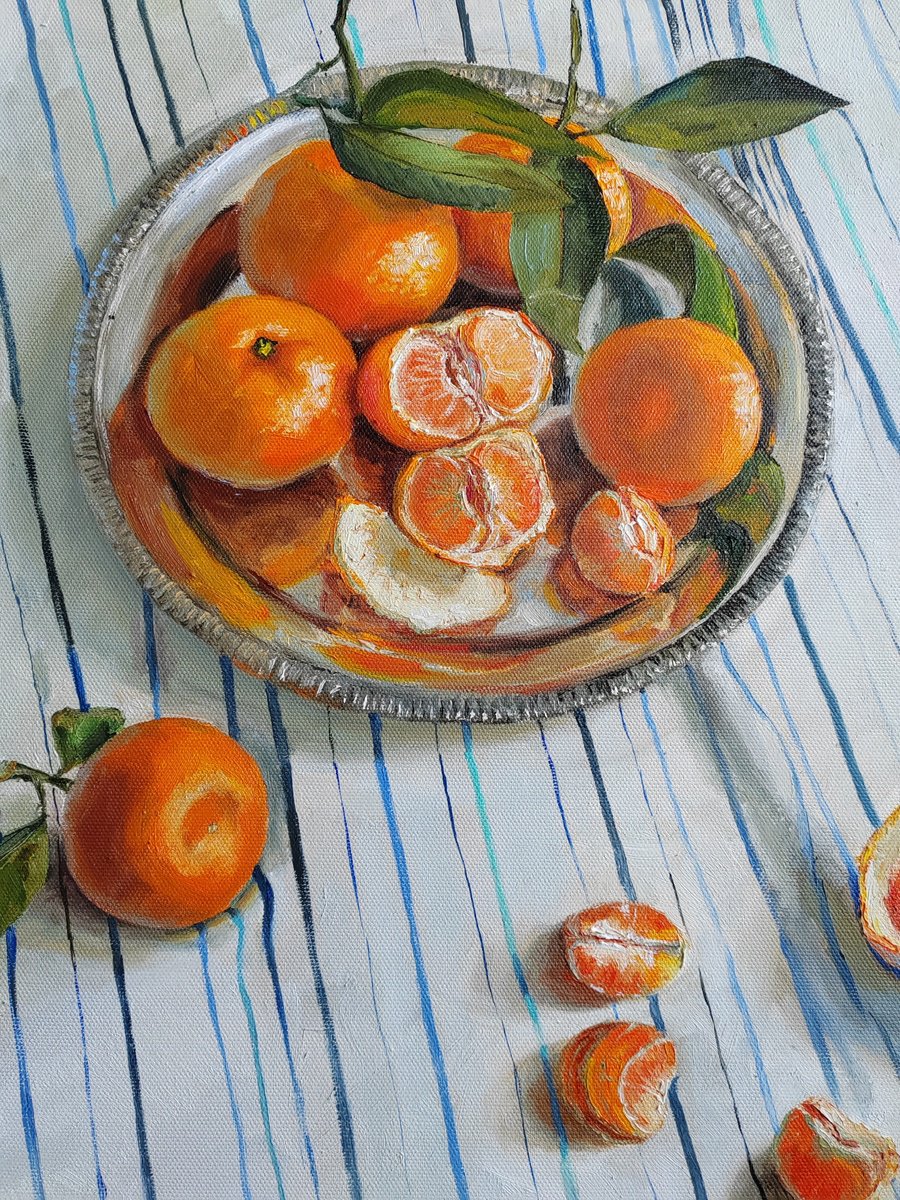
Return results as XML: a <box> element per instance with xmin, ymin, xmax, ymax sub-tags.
<box><xmin>557</xmin><ymin>1021</ymin><xmax>677</xmax><ymax>1141</ymax></box>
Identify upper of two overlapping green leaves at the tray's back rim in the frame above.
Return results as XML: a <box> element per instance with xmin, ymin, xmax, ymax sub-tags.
<box><xmin>362</xmin><ymin>67</ymin><xmax>586</xmax><ymax>155</ymax></box>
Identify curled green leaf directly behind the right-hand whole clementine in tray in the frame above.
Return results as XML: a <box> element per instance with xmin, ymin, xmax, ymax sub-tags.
<box><xmin>616</xmin><ymin>224</ymin><xmax>739</xmax><ymax>341</ymax></box>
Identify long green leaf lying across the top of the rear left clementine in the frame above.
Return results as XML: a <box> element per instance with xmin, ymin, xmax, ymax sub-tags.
<box><xmin>322</xmin><ymin>113</ymin><xmax>569</xmax><ymax>212</ymax></box>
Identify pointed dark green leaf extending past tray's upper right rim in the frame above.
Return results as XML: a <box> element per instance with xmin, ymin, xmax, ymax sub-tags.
<box><xmin>604</xmin><ymin>58</ymin><xmax>847</xmax><ymax>151</ymax></box>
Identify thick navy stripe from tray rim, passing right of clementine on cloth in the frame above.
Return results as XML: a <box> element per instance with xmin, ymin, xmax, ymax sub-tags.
<box><xmin>265</xmin><ymin>683</ymin><xmax>362</xmax><ymax>1200</ymax></box>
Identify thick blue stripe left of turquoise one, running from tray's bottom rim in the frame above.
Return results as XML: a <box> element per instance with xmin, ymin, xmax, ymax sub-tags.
<box><xmin>368</xmin><ymin>713</ymin><xmax>469</xmax><ymax>1200</ymax></box>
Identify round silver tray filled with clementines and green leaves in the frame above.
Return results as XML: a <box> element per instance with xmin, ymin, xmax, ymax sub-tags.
<box><xmin>72</xmin><ymin>13</ymin><xmax>842</xmax><ymax>720</ymax></box>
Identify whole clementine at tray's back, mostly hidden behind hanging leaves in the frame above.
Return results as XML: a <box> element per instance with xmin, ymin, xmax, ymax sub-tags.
<box><xmin>454</xmin><ymin>125</ymin><xmax>631</xmax><ymax>296</ymax></box>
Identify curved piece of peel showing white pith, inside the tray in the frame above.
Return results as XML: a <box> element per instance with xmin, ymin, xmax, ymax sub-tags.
<box><xmin>334</xmin><ymin>502</ymin><xmax>509</xmax><ymax>634</ymax></box>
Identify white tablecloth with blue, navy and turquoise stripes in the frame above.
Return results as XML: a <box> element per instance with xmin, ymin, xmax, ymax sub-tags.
<box><xmin>0</xmin><ymin>0</ymin><xmax>900</xmax><ymax>1200</ymax></box>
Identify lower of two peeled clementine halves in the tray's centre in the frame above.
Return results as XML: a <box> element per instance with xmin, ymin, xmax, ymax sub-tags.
<box><xmin>394</xmin><ymin>428</ymin><xmax>553</xmax><ymax>569</ymax></box>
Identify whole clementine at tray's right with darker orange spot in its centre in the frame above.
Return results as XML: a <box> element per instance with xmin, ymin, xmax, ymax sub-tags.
<box><xmin>572</xmin><ymin>317</ymin><xmax>762</xmax><ymax>505</ymax></box>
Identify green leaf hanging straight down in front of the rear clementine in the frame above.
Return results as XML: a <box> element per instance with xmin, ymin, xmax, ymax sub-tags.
<box><xmin>510</xmin><ymin>160</ymin><xmax>610</xmax><ymax>354</ymax></box>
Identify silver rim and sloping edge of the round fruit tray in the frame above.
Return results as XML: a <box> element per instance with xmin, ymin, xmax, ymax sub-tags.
<box><xmin>70</xmin><ymin>64</ymin><xmax>833</xmax><ymax>721</ymax></box>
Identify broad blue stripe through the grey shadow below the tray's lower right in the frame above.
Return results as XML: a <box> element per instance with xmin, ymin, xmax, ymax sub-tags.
<box><xmin>685</xmin><ymin>667</ymin><xmax>841</xmax><ymax>1103</ymax></box>
